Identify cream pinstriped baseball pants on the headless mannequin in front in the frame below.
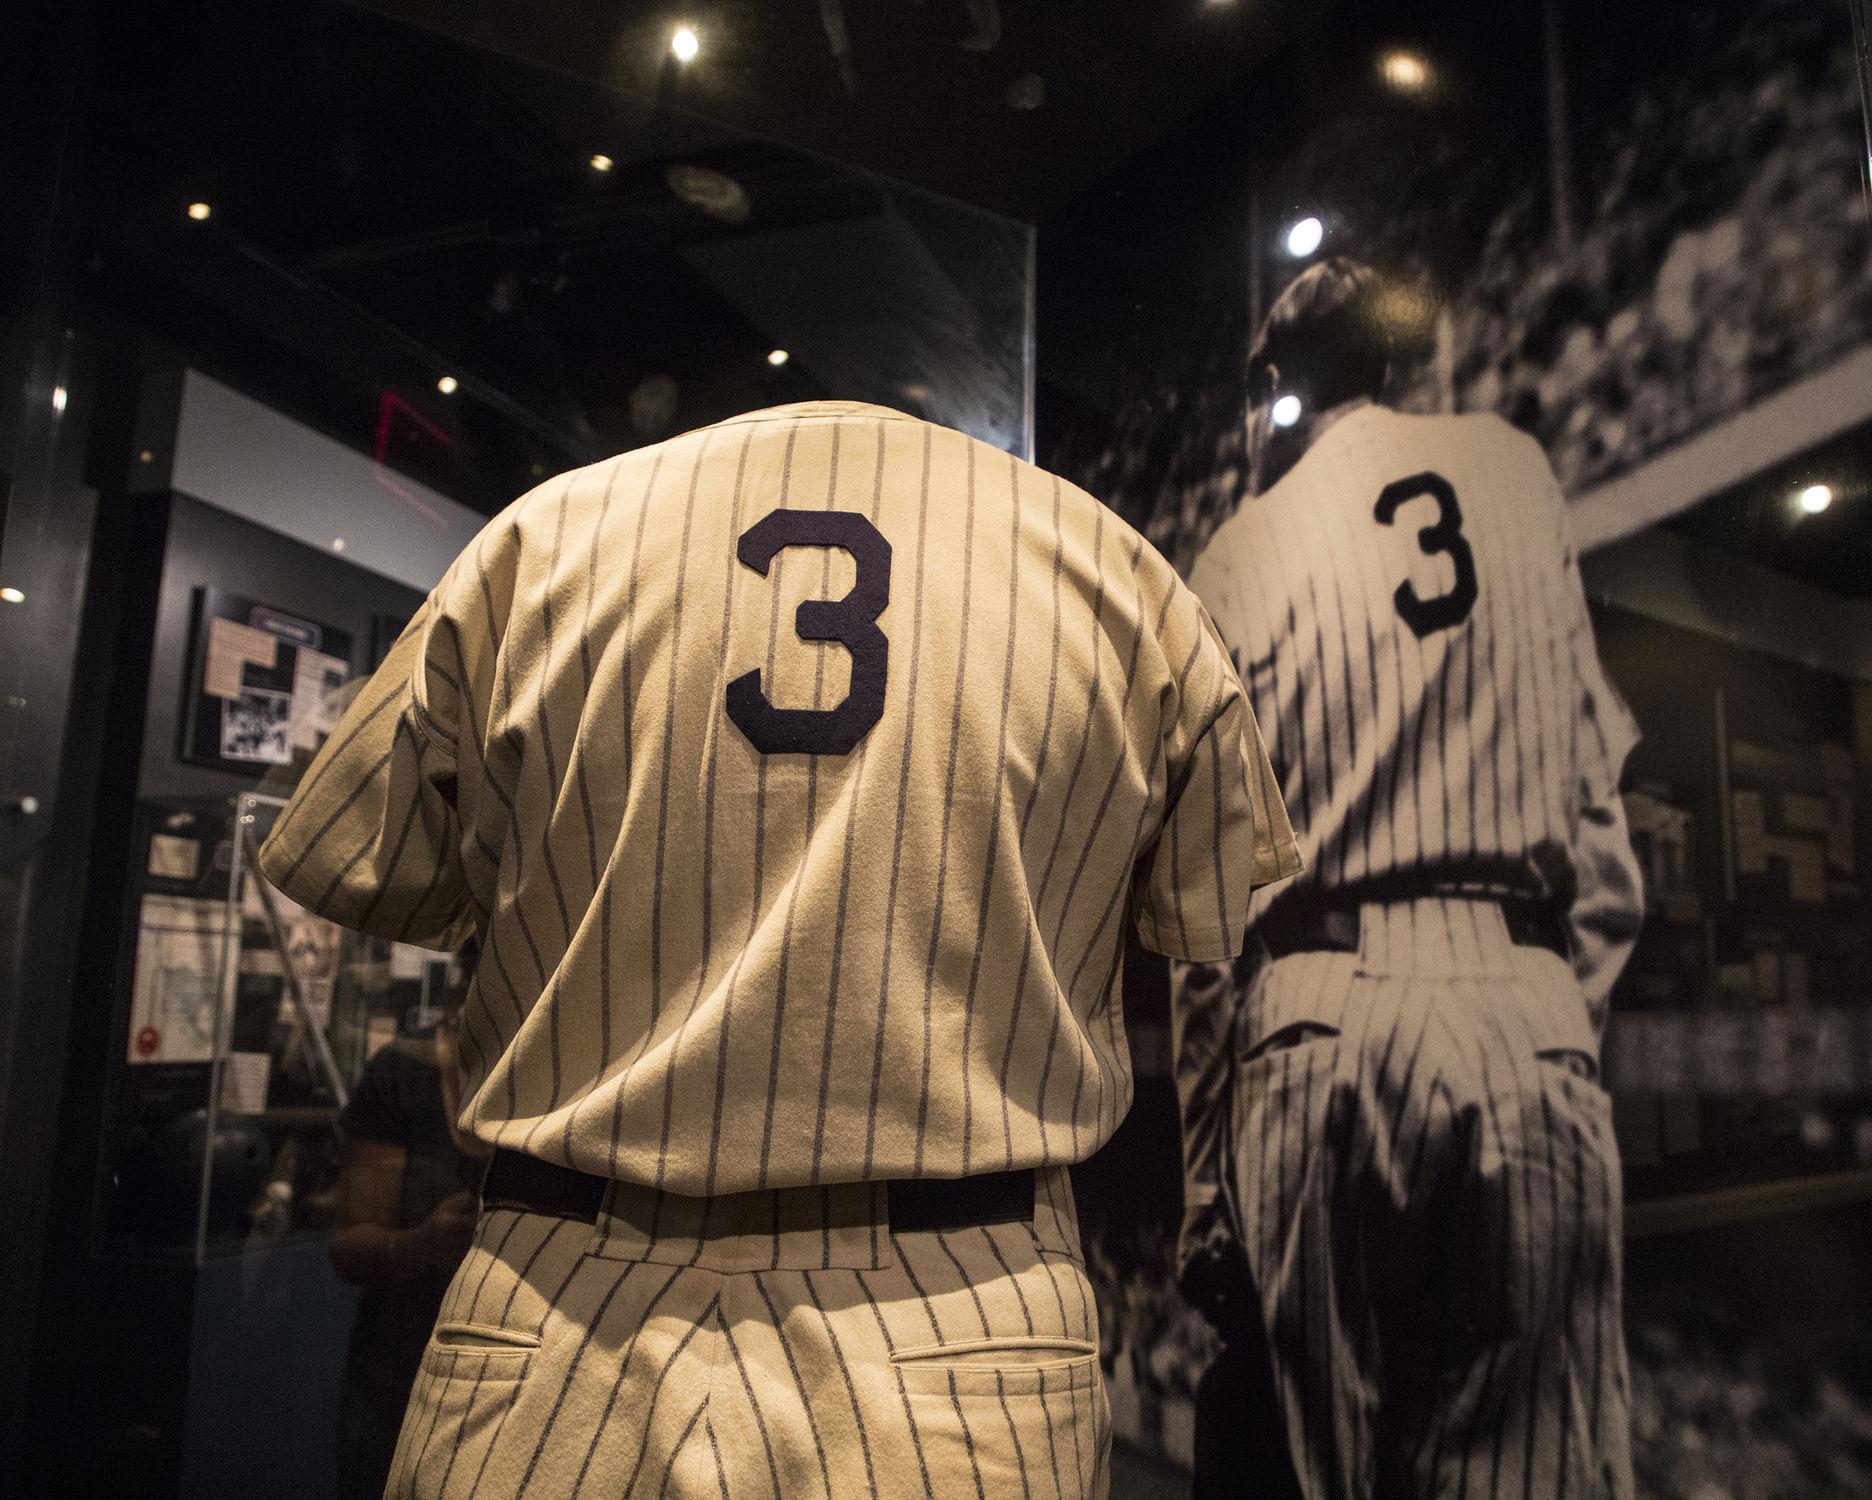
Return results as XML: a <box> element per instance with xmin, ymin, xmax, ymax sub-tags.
<box><xmin>386</xmin><ymin>1170</ymin><xmax>1110</xmax><ymax>1500</ymax></box>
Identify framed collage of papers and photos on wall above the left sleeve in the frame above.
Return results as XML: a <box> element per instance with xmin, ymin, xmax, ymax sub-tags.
<box><xmin>180</xmin><ymin>588</ymin><xmax>352</xmax><ymax>775</ymax></box>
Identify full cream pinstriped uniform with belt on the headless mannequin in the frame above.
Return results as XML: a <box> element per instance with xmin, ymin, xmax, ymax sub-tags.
<box><xmin>262</xmin><ymin>403</ymin><xmax>1297</xmax><ymax>1500</ymax></box>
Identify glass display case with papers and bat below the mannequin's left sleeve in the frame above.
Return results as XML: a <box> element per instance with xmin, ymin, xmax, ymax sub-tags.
<box><xmin>105</xmin><ymin>792</ymin><xmax>455</xmax><ymax>1262</ymax></box>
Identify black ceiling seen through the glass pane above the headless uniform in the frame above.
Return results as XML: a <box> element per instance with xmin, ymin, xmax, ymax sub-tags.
<box><xmin>84</xmin><ymin>0</ymin><xmax>1063</xmax><ymax>509</ymax></box>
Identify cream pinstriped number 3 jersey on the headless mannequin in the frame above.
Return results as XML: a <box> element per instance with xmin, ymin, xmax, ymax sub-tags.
<box><xmin>260</xmin><ymin>403</ymin><xmax>1297</xmax><ymax>1195</ymax></box>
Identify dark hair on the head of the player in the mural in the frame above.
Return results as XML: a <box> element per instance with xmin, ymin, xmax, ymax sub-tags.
<box><xmin>1249</xmin><ymin>257</ymin><xmax>1393</xmax><ymax>412</ymax></box>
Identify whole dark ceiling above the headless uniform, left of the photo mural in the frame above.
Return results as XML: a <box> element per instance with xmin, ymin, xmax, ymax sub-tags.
<box><xmin>73</xmin><ymin>0</ymin><xmax>1331</xmax><ymax>509</ymax></box>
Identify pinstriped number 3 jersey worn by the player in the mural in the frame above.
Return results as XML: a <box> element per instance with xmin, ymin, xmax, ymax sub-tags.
<box><xmin>1191</xmin><ymin>406</ymin><xmax>1642</xmax><ymax>1021</ymax></box>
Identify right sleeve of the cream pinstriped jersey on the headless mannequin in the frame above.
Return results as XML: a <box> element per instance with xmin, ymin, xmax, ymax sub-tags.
<box><xmin>1136</xmin><ymin>596</ymin><xmax>1301</xmax><ymax>963</ymax></box>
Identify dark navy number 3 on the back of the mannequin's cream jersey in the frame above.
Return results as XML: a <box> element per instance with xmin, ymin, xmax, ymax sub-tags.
<box><xmin>728</xmin><ymin>509</ymin><xmax>891</xmax><ymax>755</ymax></box>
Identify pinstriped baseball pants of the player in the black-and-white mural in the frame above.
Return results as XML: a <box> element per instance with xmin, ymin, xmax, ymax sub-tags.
<box><xmin>1232</xmin><ymin>901</ymin><xmax>1632</xmax><ymax>1500</ymax></box>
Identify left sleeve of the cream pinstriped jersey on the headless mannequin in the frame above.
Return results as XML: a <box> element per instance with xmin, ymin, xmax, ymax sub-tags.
<box><xmin>260</xmin><ymin>596</ymin><xmax>474</xmax><ymax>949</ymax></box>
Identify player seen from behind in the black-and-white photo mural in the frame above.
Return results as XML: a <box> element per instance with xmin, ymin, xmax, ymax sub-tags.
<box><xmin>1174</xmin><ymin>260</ymin><xmax>1644</xmax><ymax>1500</ymax></box>
